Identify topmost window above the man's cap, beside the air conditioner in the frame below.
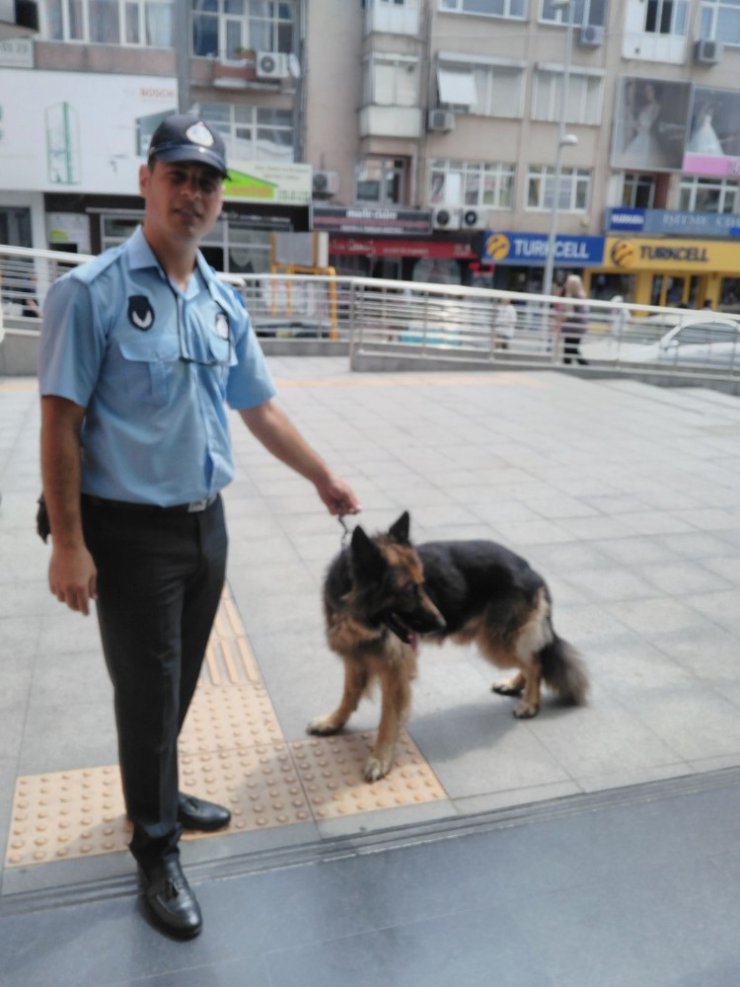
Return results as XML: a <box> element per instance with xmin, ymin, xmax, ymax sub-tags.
<box><xmin>193</xmin><ymin>0</ymin><xmax>296</xmax><ymax>59</ymax></box>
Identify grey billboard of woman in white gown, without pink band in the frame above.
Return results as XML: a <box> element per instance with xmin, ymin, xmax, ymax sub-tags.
<box><xmin>611</xmin><ymin>76</ymin><xmax>691</xmax><ymax>171</ymax></box>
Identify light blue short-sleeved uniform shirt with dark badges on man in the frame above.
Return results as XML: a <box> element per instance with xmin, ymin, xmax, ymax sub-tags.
<box><xmin>39</xmin><ymin>229</ymin><xmax>275</xmax><ymax>507</ymax></box>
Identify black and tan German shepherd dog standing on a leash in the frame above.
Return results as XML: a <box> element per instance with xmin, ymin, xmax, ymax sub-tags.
<box><xmin>307</xmin><ymin>512</ymin><xmax>588</xmax><ymax>781</ymax></box>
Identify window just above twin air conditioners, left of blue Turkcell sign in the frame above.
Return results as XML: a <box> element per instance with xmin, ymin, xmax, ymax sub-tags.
<box><xmin>429</xmin><ymin>160</ymin><xmax>515</xmax><ymax>209</ymax></box>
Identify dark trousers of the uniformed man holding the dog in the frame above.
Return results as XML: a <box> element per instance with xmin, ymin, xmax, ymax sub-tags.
<box><xmin>83</xmin><ymin>497</ymin><xmax>227</xmax><ymax>866</ymax></box>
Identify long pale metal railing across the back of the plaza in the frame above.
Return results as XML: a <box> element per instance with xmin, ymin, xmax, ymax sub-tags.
<box><xmin>0</xmin><ymin>246</ymin><xmax>740</xmax><ymax>383</ymax></box>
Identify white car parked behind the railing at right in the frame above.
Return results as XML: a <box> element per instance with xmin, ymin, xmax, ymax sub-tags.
<box><xmin>581</xmin><ymin>312</ymin><xmax>740</xmax><ymax>371</ymax></box>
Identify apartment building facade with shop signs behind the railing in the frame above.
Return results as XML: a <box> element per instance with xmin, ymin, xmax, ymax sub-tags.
<box><xmin>0</xmin><ymin>0</ymin><xmax>740</xmax><ymax>306</ymax></box>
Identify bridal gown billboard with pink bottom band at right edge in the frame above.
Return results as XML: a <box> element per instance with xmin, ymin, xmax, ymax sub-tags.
<box><xmin>683</xmin><ymin>86</ymin><xmax>740</xmax><ymax>178</ymax></box>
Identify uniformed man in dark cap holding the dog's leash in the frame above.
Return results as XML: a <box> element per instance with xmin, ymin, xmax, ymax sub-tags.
<box><xmin>39</xmin><ymin>114</ymin><xmax>359</xmax><ymax>938</ymax></box>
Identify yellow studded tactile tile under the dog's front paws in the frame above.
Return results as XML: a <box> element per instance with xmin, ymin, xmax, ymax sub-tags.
<box><xmin>290</xmin><ymin>733</ymin><xmax>447</xmax><ymax>819</ymax></box>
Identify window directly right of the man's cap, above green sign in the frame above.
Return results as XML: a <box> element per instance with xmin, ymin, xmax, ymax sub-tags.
<box><xmin>200</xmin><ymin>103</ymin><xmax>294</xmax><ymax>162</ymax></box>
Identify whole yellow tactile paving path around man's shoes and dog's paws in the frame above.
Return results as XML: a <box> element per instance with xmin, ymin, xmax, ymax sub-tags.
<box><xmin>5</xmin><ymin>589</ymin><xmax>447</xmax><ymax>867</ymax></box>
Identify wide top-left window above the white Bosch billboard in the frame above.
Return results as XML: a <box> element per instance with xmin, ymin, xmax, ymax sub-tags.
<box><xmin>45</xmin><ymin>0</ymin><xmax>173</xmax><ymax>48</ymax></box>
